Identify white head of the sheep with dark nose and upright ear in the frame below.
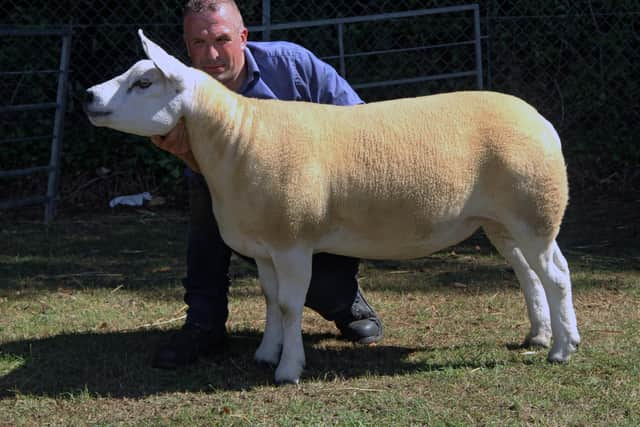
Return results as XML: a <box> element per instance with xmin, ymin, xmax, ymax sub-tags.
<box><xmin>84</xmin><ymin>30</ymin><xmax>194</xmax><ymax>136</ymax></box>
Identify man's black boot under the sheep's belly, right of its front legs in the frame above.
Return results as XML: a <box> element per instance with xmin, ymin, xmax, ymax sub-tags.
<box><xmin>335</xmin><ymin>289</ymin><xmax>384</xmax><ymax>344</ymax></box>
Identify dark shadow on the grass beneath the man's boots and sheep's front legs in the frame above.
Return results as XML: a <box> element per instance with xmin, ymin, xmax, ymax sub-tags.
<box><xmin>0</xmin><ymin>330</ymin><xmax>496</xmax><ymax>398</ymax></box>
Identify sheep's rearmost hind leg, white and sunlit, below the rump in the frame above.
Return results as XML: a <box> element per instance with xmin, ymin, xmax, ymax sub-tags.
<box><xmin>520</xmin><ymin>236</ymin><xmax>580</xmax><ymax>362</ymax></box>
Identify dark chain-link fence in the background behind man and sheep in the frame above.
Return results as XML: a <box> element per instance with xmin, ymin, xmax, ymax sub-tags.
<box><xmin>0</xmin><ymin>0</ymin><xmax>640</xmax><ymax>214</ymax></box>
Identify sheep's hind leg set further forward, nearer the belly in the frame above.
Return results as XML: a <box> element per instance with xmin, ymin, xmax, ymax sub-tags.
<box><xmin>482</xmin><ymin>223</ymin><xmax>551</xmax><ymax>347</ymax></box>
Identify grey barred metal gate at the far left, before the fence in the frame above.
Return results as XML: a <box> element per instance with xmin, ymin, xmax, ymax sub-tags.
<box><xmin>0</xmin><ymin>27</ymin><xmax>72</xmax><ymax>223</ymax></box>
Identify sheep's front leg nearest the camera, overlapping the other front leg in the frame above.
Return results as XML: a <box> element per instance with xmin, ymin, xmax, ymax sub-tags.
<box><xmin>272</xmin><ymin>248</ymin><xmax>312</xmax><ymax>384</ymax></box>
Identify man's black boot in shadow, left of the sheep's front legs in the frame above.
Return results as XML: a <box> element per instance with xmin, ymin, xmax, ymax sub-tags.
<box><xmin>152</xmin><ymin>323</ymin><xmax>227</xmax><ymax>369</ymax></box>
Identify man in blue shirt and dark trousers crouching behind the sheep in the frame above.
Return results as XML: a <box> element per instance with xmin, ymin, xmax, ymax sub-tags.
<box><xmin>152</xmin><ymin>0</ymin><xmax>383</xmax><ymax>369</ymax></box>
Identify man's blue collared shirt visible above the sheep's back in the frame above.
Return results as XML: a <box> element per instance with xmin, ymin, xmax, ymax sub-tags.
<box><xmin>238</xmin><ymin>42</ymin><xmax>363</xmax><ymax>105</ymax></box>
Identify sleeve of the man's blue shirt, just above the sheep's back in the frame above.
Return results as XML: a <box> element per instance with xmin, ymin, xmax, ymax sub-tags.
<box><xmin>296</xmin><ymin>49</ymin><xmax>364</xmax><ymax>105</ymax></box>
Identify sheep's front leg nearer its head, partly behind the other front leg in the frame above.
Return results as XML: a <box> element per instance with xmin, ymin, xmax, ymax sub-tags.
<box><xmin>255</xmin><ymin>258</ymin><xmax>282</xmax><ymax>365</ymax></box>
